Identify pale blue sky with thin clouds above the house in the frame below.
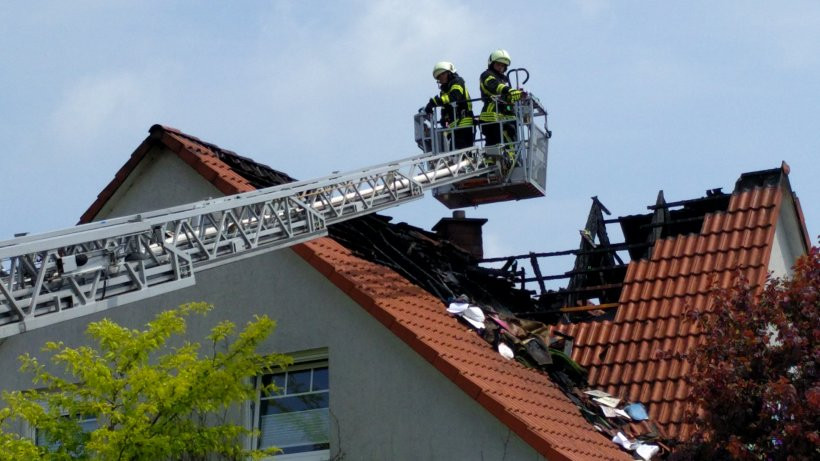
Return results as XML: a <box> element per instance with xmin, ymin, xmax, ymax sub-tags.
<box><xmin>0</xmin><ymin>0</ymin><xmax>820</xmax><ymax>282</ymax></box>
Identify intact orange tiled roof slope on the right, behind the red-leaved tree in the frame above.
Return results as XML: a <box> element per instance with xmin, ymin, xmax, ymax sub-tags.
<box><xmin>561</xmin><ymin>164</ymin><xmax>805</xmax><ymax>438</ymax></box>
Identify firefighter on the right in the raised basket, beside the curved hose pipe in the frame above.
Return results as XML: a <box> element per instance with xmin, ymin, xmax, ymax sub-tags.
<box><xmin>479</xmin><ymin>49</ymin><xmax>525</xmax><ymax>156</ymax></box>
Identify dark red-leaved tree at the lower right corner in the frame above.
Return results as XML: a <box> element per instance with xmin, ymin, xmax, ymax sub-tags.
<box><xmin>681</xmin><ymin>247</ymin><xmax>820</xmax><ymax>460</ymax></box>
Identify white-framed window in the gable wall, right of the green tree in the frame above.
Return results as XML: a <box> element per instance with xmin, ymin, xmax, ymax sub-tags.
<box><xmin>257</xmin><ymin>361</ymin><xmax>330</xmax><ymax>459</ymax></box>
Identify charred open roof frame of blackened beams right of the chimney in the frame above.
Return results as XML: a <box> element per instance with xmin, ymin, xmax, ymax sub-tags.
<box><xmin>482</xmin><ymin>184</ymin><xmax>732</xmax><ymax>323</ymax></box>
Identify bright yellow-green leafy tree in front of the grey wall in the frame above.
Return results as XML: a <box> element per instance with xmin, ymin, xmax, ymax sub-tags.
<box><xmin>0</xmin><ymin>303</ymin><xmax>291</xmax><ymax>460</ymax></box>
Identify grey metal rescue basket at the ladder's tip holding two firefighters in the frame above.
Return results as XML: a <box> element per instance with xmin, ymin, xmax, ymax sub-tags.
<box><xmin>413</xmin><ymin>94</ymin><xmax>552</xmax><ymax>208</ymax></box>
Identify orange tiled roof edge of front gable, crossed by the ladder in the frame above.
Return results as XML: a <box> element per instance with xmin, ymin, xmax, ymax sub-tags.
<box><xmin>81</xmin><ymin>125</ymin><xmax>632</xmax><ymax>460</ymax></box>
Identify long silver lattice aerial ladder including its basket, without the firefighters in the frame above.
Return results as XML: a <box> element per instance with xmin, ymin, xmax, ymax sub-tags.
<box><xmin>0</xmin><ymin>88</ymin><xmax>550</xmax><ymax>338</ymax></box>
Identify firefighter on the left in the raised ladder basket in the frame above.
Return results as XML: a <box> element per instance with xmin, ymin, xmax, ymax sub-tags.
<box><xmin>424</xmin><ymin>61</ymin><xmax>475</xmax><ymax>149</ymax></box>
